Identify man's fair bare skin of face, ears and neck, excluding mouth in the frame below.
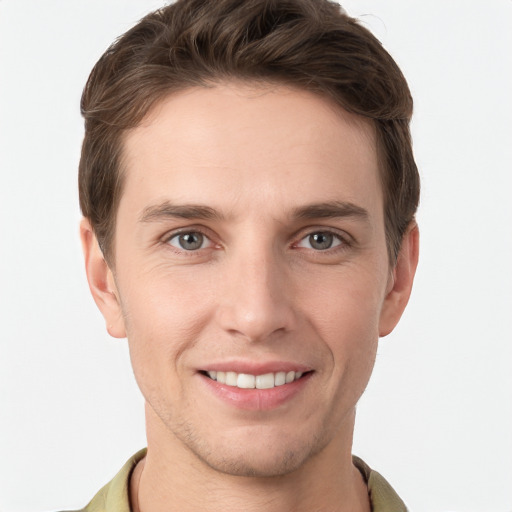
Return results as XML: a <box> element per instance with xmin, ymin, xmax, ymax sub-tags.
<box><xmin>81</xmin><ymin>83</ymin><xmax>418</xmax><ymax>512</ymax></box>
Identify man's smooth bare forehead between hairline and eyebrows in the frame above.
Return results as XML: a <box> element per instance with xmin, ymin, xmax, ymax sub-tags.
<box><xmin>119</xmin><ymin>83</ymin><xmax>382</xmax><ymax>220</ymax></box>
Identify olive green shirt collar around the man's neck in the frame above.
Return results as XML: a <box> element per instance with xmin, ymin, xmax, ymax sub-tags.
<box><xmin>79</xmin><ymin>449</ymin><xmax>407</xmax><ymax>512</ymax></box>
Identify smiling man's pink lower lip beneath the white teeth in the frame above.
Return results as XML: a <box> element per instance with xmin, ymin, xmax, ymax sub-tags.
<box><xmin>199</xmin><ymin>372</ymin><xmax>313</xmax><ymax>411</ymax></box>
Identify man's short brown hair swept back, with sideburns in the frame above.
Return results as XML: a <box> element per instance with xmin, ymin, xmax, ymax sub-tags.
<box><xmin>79</xmin><ymin>0</ymin><xmax>419</xmax><ymax>263</ymax></box>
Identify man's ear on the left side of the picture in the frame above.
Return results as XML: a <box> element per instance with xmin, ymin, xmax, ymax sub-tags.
<box><xmin>80</xmin><ymin>219</ymin><xmax>126</xmax><ymax>338</ymax></box>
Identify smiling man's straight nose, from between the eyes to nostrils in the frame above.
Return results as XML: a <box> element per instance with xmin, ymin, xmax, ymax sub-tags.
<box><xmin>217</xmin><ymin>241</ymin><xmax>296</xmax><ymax>342</ymax></box>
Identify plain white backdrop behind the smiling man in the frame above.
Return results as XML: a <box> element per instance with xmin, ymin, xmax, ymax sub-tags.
<box><xmin>0</xmin><ymin>0</ymin><xmax>512</xmax><ymax>512</ymax></box>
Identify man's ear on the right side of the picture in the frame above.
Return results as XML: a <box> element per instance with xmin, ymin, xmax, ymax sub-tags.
<box><xmin>379</xmin><ymin>221</ymin><xmax>420</xmax><ymax>336</ymax></box>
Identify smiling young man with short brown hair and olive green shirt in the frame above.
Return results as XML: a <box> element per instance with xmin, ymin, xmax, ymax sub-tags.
<box><xmin>79</xmin><ymin>0</ymin><xmax>419</xmax><ymax>512</ymax></box>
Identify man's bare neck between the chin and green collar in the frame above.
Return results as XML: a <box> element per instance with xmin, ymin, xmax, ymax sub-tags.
<box><xmin>130</xmin><ymin>406</ymin><xmax>370</xmax><ymax>512</ymax></box>
